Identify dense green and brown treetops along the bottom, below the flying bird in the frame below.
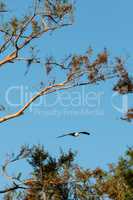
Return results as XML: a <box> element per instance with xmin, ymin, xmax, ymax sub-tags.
<box><xmin>0</xmin><ymin>145</ymin><xmax>133</xmax><ymax>200</ymax></box>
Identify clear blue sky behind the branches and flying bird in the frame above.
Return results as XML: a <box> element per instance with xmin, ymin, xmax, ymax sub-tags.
<box><xmin>0</xmin><ymin>0</ymin><xmax>133</xmax><ymax>186</ymax></box>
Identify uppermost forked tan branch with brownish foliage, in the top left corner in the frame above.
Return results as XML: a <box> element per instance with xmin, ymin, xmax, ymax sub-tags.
<box><xmin>0</xmin><ymin>0</ymin><xmax>72</xmax><ymax>67</ymax></box>
